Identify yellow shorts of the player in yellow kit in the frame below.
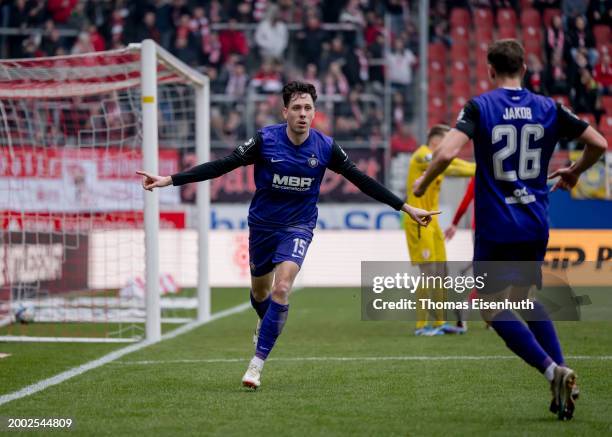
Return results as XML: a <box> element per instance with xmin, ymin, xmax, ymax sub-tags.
<box><xmin>404</xmin><ymin>222</ymin><xmax>446</xmax><ymax>264</ymax></box>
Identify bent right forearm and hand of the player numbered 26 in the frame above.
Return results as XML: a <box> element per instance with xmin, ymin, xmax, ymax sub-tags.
<box><xmin>548</xmin><ymin>126</ymin><xmax>608</xmax><ymax>191</ymax></box>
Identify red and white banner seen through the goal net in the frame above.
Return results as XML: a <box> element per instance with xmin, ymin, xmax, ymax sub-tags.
<box><xmin>0</xmin><ymin>147</ymin><xmax>180</xmax><ymax>213</ymax></box>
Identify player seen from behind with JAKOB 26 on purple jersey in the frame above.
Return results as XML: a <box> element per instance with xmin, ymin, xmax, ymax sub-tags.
<box><xmin>414</xmin><ymin>39</ymin><xmax>607</xmax><ymax>420</ymax></box>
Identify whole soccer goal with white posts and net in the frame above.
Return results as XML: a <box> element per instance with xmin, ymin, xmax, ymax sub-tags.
<box><xmin>0</xmin><ymin>41</ymin><xmax>210</xmax><ymax>342</ymax></box>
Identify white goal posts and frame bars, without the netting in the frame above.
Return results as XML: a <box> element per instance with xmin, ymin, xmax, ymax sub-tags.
<box><xmin>0</xmin><ymin>39</ymin><xmax>211</xmax><ymax>343</ymax></box>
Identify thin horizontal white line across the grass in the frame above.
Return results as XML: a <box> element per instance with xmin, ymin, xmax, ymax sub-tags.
<box><xmin>115</xmin><ymin>355</ymin><xmax>612</xmax><ymax>366</ymax></box>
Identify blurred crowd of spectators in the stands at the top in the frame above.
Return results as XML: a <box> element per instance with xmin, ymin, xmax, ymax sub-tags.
<box><xmin>1</xmin><ymin>0</ymin><xmax>612</xmax><ymax>151</ymax></box>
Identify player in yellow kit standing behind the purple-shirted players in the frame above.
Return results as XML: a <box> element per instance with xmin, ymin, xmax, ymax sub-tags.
<box><xmin>403</xmin><ymin>124</ymin><xmax>476</xmax><ymax>336</ymax></box>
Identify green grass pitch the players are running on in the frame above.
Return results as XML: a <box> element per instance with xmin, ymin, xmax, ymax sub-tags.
<box><xmin>0</xmin><ymin>289</ymin><xmax>612</xmax><ymax>435</ymax></box>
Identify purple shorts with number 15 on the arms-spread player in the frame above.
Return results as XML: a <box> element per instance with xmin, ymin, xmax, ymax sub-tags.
<box><xmin>249</xmin><ymin>227</ymin><xmax>312</xmax><ymax>276</ymax></box>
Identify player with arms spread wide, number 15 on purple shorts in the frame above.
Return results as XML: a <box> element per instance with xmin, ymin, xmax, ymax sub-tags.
<box><xmin>138</xmin><ymin>82</ymin><xmax>438</xmax><ymax>388</ymax></box>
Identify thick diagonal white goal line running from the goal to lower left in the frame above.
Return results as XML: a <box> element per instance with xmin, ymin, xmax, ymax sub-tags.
<box><xmin>0</xmin><ymin>300</ymin><xmax>253</xmax><ymax>405</ymax></box>
